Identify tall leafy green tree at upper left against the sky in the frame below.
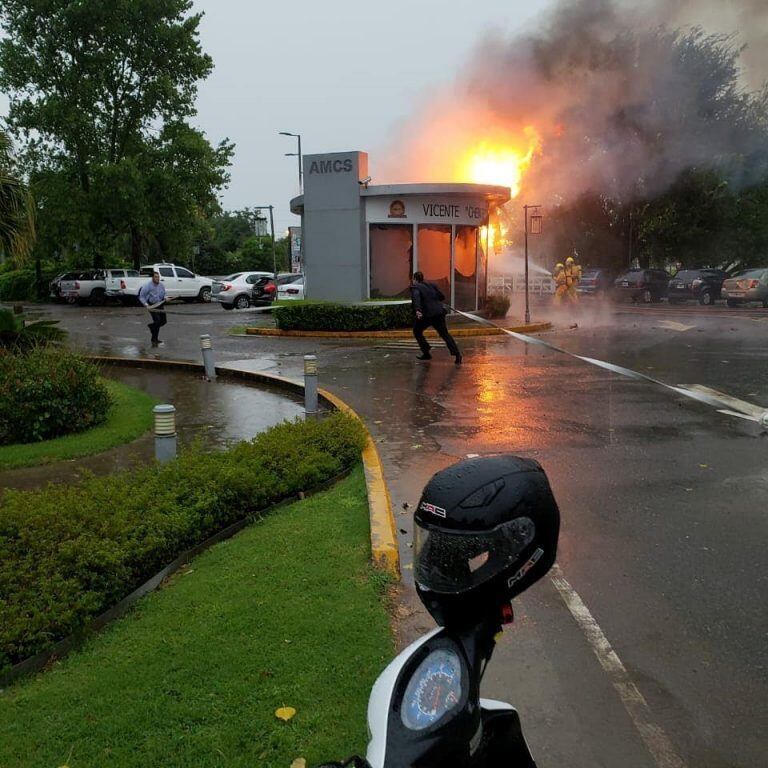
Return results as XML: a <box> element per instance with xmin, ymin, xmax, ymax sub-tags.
<box><xmin>0</xmin><ymin>0</ymin><xmax>233</xmax><ymax>266</ymax></box>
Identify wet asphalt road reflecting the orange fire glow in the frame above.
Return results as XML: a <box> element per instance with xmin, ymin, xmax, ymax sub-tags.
<box><xmin>13</xmin><ymin>306</ymin><xmax>768</xmax><ymax>768</ymax></box>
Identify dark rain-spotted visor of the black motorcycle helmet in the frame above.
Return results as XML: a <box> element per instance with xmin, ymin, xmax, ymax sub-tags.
<box><xmin>414</xmin><ymin>517</ymin><xmax>536</xmax><ymax>594</ymax></box>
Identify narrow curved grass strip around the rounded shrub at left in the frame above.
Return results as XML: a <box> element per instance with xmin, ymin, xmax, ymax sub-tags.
<box><xmin>0</xmin><ymin>379</ymin><xmax>157</xmax><ymax>470</ymax></box>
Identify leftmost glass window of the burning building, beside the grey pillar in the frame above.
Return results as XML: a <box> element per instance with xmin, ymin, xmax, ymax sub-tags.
<box><xmin>369</xmin><ymin>224</ymin><xmax>413</xmax><ymax>299</ymax></box>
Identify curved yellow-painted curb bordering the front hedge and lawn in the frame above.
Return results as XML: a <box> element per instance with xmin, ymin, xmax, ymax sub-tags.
<box><xmin>86</xmin><ymin>355</ymin><xmax>400</xmax><ymax>578</ymax></box>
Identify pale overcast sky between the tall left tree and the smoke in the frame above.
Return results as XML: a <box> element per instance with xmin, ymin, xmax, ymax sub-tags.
<box><xmin>195</xmin><ymin>0</ymin><xmax>546</xmax><ymax>231</ymax></box>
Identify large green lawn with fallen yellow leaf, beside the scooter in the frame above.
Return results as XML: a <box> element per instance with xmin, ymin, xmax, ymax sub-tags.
<box><xmin>0</xmin><ymin>468</ymin><xmax>393</xmax><ymax>768</ymax></box>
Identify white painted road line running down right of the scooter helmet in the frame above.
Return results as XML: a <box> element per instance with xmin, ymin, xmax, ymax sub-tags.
<box><xmin>551</xmin><ymin>564</ymin><xmax>686</xmax><ymax>768</ymax></box>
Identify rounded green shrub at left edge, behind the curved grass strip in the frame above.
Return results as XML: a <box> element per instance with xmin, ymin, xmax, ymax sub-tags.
<box><xmin>0</xmin><ymin>347</ymin><xmax>111</xmax><ymax>445</ymax></box>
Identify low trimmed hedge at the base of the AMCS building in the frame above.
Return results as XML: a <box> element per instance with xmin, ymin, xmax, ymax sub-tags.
<box><xmin>272</xmin><ymin>302</ymin><xmax>413</xmax><ymax>331</ymax></box>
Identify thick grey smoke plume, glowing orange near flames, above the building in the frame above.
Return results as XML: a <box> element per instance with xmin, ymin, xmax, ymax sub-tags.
<box><xmin>377</xmin><ymin>0</ymin><xmax>768</xmax><ymax>205</ymax></box>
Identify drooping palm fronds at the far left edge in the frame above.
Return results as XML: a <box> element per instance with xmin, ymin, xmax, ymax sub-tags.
<box><xmin>0</xmin><ymin>130</ymin><xmax>35</xmax><ymax>266</ymax></box>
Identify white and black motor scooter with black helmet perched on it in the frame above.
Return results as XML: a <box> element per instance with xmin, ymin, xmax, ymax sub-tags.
<box><xmin>319</xmin><ymin>457</ymin><xmax>559</xmax><ymax>768</ymax></box>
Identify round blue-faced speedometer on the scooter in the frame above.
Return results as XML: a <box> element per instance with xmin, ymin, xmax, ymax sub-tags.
<box><xmin>400</xmin><ymin>648</ymin><xmax>462</xmax><ymax>731</ymax></box>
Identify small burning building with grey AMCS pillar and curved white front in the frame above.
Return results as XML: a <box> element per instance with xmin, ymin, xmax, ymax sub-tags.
<box><xmin>291</xmin><ymin>152</ymin><xmax>512</xmax><ymax>311</ymax></box>
